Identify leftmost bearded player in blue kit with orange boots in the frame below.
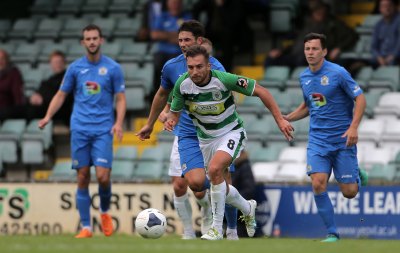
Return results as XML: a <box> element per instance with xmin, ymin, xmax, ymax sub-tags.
<box><xmin>39</xmin><ymin>25</ymin><xmax>126</xmax><ymax>238</ymax></box>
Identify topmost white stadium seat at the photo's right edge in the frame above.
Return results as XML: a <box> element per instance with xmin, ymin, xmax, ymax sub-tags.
<box><xmin>374</xmin><ymin>92</ymin><xmax>400</xmax><ymax>118</ymax></box>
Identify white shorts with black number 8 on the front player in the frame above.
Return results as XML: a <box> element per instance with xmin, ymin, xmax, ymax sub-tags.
<box><xmin>199</xmin><ymin>128</ymin><xmax>247</xmax><ymax>167</ymax></box>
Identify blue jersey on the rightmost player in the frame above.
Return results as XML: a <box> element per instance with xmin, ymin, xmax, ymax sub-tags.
<box><xmin>300</xmin><ymin>60</ymin><xmax>363</xmax><ymax>145</ymax></box>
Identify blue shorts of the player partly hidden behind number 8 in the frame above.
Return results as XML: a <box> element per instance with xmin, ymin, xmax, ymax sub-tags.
<box><xmin>178</xmin><ymin>136</ymin><xmax>235</xmax><ymax>176</ymax></box>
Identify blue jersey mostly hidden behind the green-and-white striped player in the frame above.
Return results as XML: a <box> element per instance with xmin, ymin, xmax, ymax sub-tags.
<box><xmin>161</xmin><ymin>54</ymin><xmax>225</xmax><ymax>137</ymax></box>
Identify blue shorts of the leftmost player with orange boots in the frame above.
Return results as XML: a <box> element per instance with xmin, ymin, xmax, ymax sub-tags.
<box><xmin>71</xmin><ymin>131</ymin><xmax>113</xmax><ymax>169</ymax></box>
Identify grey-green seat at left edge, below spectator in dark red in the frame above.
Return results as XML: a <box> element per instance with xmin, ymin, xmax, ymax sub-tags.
<box><xmin>0</xmin><ymin>119</ymin><xmax>26</xmax><ymax>163</ymax></box>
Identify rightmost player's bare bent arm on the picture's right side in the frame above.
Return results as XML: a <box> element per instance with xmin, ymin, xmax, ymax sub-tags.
<box><xmin>342</xmin><ymin>94</ymin><xmax>367</xmax><ymax>147</ymax></box>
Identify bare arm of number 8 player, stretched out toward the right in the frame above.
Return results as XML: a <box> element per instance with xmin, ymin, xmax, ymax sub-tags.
<box><xmin>253</xmin><ymin>84</ymin><xmax>294</xmax><ymax>141</ymax></box>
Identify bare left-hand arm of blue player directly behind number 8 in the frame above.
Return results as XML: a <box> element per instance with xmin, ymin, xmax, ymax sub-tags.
<box><xmin>136</xmin><ymin>86</ymin><xmax>171</xmax><ymax>141</ymax></box>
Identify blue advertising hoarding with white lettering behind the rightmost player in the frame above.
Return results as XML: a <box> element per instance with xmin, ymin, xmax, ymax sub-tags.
<box><xmin>256</xmin><ymin>186</ymin><xmax>400</xmax><ymax>239</ymax></box>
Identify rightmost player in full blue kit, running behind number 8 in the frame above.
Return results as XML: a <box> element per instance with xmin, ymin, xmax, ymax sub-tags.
<box><xmin>286</xmin><ymin>33</ymin><xmax>367</xmax><ymax>242</ymax></box>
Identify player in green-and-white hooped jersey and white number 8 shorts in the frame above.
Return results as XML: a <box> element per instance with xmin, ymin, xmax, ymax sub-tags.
<box><xmin>164</xmin><ymin>45</ymin><xmax>293</xmax><ymax>240</ymax></box>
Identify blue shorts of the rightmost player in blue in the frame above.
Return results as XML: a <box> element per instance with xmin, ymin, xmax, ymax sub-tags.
<box><xmin>307</xmin><ymin>143</ymin><xmax>360</xmax><ymax>184</ymax></box>
